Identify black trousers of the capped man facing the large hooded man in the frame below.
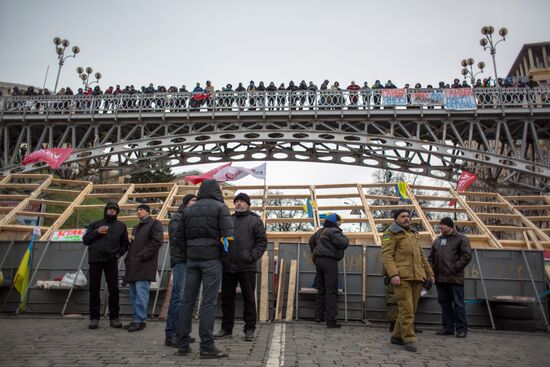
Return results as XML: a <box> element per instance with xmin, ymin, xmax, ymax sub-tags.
<box><xmin>222</xmin><ymin>271</ymin><xmax>257</xmax><ymax>333</ymax></box>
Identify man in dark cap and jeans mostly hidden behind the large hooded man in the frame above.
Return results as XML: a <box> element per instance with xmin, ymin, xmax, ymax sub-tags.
<box><xmin>164</xmin><ymin>194</ymin><xmax>197</xmax><ymax>348</ymax></box>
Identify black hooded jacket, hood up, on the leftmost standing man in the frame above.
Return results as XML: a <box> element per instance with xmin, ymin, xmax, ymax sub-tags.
<box><xmin>82</xmin><ymin>203</ymin><xmax>129</xmax><ymax>263</ymax></box>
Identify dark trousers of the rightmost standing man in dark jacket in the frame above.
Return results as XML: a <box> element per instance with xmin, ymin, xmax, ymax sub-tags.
<box><xmin>436</xmin><ymin>283</ymin><xmax>468</xmax><ymax>332</ymax></box>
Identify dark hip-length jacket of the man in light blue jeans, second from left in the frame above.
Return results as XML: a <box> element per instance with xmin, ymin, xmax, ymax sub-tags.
<box><xmin>124</xmin><ymin>216</ymin><xmax>164</xmax><ymax>282</ymax></box>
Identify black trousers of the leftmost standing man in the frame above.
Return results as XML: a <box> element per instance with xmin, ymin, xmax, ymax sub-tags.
<box><xmin>88</xmin><ymin>259</ymin><xmax>120</xmax><ymax>320</ymax></box>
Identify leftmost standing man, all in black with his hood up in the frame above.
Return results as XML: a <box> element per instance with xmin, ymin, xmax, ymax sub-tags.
<box><xmin>82</xmin><ymin>202</ymin><xmax>129</xmax><ymax>329</ymax></box>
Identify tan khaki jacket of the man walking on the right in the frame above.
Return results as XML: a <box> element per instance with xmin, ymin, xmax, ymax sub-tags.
<box><xmin>382</xmin><ymin>222</ymin><xmax>433</xmax><ymax>281</ymax></box>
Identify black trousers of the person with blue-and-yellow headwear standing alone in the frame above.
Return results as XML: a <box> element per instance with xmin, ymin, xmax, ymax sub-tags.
<box><xmin>315</xmin><ymin>257</ymin><xmax>338</xmax><ymax>325</ymax></box>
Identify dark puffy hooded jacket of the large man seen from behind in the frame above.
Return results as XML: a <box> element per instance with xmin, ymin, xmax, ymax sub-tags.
<box><xmin>174</xmin><ymin>180</ymin><xmax>234</xmax><ymax>261</ymax></box>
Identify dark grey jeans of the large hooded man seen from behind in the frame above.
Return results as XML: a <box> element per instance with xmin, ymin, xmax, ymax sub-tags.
<box><xmin>177</xmin><ymin>259</ymin><xmax>222</xmax><ymax>352</ymax></box>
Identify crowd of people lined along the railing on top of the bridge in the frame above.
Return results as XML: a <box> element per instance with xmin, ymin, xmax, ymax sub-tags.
<box><xmin>3</xmin><ymin>77</ymin><xmax>539</xmax><ymax>113</ymax></box>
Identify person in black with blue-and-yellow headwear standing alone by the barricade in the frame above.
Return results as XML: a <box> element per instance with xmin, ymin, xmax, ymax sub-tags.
<box><xmin>309</xmin><ymin>213</ymin><xmax>349</xmax><ymax>329</ymax></box>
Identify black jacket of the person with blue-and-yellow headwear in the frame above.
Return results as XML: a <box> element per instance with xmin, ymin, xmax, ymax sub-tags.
<box><xmin>309</xmin><ymin>221</ymin><xmax>349</xmax><ymax>260</ymax></box>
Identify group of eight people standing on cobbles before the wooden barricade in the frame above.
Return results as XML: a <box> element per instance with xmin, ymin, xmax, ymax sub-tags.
<box><xmin>83</xmin><ymin>180</ymin><xmax>471</xmax><ymax>358</ymax></box>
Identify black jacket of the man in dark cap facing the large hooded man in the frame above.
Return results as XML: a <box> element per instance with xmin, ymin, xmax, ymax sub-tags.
<box><xmin>222</xmin><ymin>210</ymin><xmax>267</xmax><ymax>273</ymax></box>
